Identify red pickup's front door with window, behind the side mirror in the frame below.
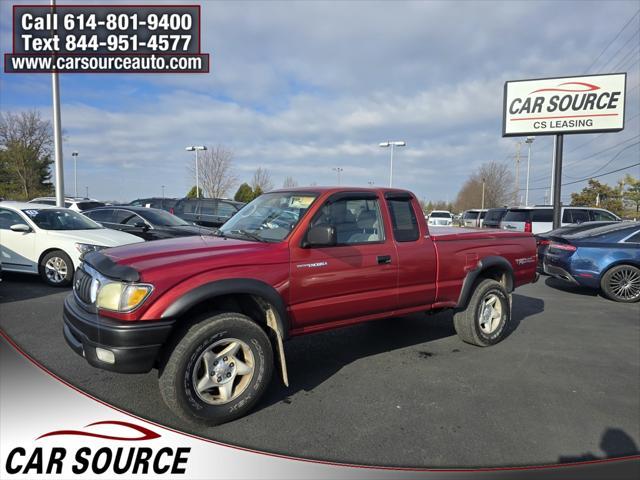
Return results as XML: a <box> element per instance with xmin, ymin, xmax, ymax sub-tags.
<box><xmin>289</xmin><ymin>192</ymin><xmax>398</xmax><ymax>331</ymax></box>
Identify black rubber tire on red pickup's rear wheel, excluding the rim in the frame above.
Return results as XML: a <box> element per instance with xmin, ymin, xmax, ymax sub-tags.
<box><xmin>453</xmin><ymin>279</ymin><xmax>511</xmax><ymax>347</ymax></box>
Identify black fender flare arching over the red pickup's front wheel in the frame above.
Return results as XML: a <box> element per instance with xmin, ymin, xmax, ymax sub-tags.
<box><xmin>160</xmin><ymin>278</ymin><xmax>289</xmax><ymax>340</ymax></box>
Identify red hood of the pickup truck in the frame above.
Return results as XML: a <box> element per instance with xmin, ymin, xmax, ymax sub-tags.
<box><xmin>103</xmin><ymin>235</ymin><xmax>287</xmax><ymax>281</ymax></box>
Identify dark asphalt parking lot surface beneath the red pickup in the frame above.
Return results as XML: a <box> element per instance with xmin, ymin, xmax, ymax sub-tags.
<box><xmin>0</xmin><ymin>273</ymin><xmax>640</xmax><ymax>467</ymax></box>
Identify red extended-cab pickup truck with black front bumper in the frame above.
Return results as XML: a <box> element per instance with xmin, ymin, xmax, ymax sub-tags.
<box><xmin>64</xmin><ymin>187</ymin><xmax>537</xmax><ymax>424</ymax></box>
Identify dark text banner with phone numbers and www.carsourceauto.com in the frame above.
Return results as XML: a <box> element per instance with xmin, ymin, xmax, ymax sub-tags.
<box><xmin>5</xmin><ymin>5</ymin><xmax>209</xmax><ymax>73</ymax></box>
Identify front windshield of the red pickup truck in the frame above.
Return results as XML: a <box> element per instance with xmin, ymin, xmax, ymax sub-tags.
<box><xmin>219</xmin><ymin>192</ymin><xmax>318</xmax><ymax>242</ymax></box>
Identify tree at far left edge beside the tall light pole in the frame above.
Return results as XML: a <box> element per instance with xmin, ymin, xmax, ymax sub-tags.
<box><xmin>0</xmin><ymin>111</ymin><xmax>53</xmax><ymax>199</ymax></box>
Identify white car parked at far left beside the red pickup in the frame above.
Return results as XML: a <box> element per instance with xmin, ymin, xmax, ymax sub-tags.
<box><xmin>0</xmin><ymin>202</ymin><xmax>144</xmax><ymax>286</ymax></box>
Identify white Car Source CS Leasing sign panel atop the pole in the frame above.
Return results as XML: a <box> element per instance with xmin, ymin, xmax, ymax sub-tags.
<box><xmin>502</xmin><ymin>73</ymin><xmax>627</xmax><ymax>137</ymax></box>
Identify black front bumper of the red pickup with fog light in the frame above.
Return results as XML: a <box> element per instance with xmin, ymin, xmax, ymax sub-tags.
<box><xmin>63</xmin><ymin>294</ymin><xmax>175</xmax><ymax>373</ymax></box>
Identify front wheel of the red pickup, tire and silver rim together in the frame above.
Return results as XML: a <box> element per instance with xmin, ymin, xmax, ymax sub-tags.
<box><xmin>159</xmin><ymin>313</ymin><xmax>273</xmax><ymax>425</ymax></box>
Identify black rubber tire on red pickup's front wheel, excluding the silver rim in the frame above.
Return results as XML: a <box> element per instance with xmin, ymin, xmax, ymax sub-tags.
<box><xmin>159</xmin><ymin>313</ymin><xmax>273</xmax><ymax>425</ymax></box>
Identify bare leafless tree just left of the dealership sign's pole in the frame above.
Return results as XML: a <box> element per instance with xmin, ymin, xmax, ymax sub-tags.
<box><xmin>455</xmin><ymin>161</ymin><xmax>513</xmax><ymax>211</ymax></box>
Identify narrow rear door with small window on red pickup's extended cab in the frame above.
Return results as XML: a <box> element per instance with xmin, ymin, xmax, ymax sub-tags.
<box><xmin>385</xmin><ymin>192</ymin><xmax>438</xmax><ymax>310</ymax></box>
